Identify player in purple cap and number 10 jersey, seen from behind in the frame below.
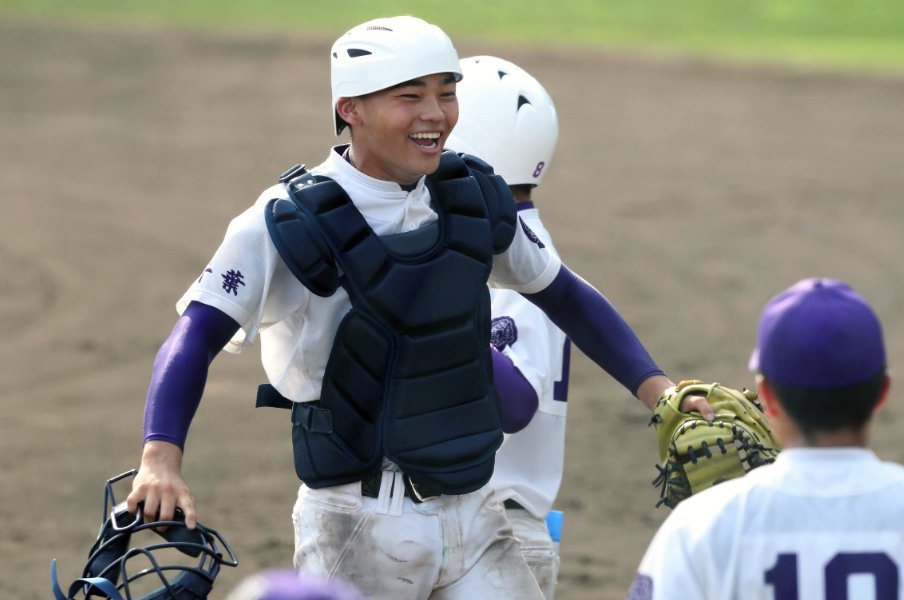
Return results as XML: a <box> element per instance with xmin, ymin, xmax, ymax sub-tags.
<box><xmin>629</xmin><ymin>279</ymin><xmax>904</xmax><ymax>600</ymax></box>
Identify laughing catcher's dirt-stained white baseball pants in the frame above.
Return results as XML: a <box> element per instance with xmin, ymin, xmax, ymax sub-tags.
<box><xmin>292</xmin><ymin>471</ymin><xmax>543</xmax><ymax>600</ymax></box>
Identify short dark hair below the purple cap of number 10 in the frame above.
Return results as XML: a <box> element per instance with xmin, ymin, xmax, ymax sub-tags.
<box><xmin>769</xmin><ymin>369</ymin><xmax>885</xmax><ymax>435</ymax></box>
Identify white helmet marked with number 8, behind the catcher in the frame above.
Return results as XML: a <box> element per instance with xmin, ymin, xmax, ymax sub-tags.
<box><xmin>446</xmin><ymin>56</ymin><xmax>559</xmax><ymax>185</ymax></box>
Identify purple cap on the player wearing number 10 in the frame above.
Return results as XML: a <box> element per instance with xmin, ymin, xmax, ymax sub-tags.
<box><xmin>750</xmin><ymin>279</ymin><xmax>885</xmax><ymax>389</ymax></box>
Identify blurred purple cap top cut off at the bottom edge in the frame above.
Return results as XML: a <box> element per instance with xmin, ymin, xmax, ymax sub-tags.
<box><xmin>227</xmin><ymin>569</ymin><xmax>363</xmax><ymax>600</ymax></box>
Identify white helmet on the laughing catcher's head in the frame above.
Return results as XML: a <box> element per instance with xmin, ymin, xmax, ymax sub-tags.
<box><xmin>330</xmin><ymin>16</ymin><xmax>461</xmax><ymax>135</ymax></box>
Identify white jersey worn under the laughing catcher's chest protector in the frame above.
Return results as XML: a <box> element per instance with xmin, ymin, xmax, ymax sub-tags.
<box><xmin>176</xmin><ymin>145</ymin><xmax>561</xmax><ymax>402</ymax></box>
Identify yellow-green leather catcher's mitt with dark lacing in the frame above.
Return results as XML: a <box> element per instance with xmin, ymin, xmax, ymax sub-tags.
<box><xmin>650</xmin><ymin>380</ymin><xmax>780</xmax><ymax>508</ymax></box>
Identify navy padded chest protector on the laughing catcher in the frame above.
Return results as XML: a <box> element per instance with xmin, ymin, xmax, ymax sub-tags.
<box><xmin>258</xmin><ymin>152</ymin><xmax>516</xmax><ymax>496</ymax></box>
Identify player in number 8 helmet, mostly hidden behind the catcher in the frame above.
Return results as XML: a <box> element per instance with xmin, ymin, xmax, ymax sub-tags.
<box><xmin>446</xmin><ymin>56</ymin><xmax>571</xmax><ymax>600</ymax></box>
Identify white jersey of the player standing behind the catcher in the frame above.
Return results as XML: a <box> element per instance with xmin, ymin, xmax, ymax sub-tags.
<box><xmin>490</xmin><ymin>208</ymin><xmax>570</xmax><ymax>519</ymax></box>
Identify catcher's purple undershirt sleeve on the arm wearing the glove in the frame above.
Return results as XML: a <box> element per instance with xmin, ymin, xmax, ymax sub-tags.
<box><xmin>523</xmin><ymin>264</ymin><xmax>664</xmax><ymax>396</ymax></box>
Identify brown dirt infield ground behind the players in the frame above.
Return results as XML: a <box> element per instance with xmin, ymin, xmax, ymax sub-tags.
<box><xmin>0</xmin><ymin>21</ymin><xmax>904</xmax><ymax>600</ymax></box>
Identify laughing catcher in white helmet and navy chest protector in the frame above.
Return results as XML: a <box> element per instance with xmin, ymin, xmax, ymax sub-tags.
<box><xmin>128</xmin><ymin>17</ymin><xmax>712</xmax><ymax>600</ymax></box>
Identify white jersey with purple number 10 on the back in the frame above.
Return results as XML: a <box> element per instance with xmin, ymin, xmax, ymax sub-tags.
<box><xmin>629</xmin><ymin>448</ymin><xmax>904</xmax><ymax>600</ymax></box>
